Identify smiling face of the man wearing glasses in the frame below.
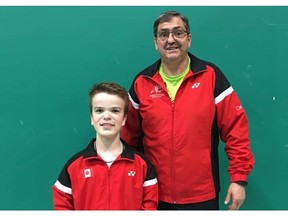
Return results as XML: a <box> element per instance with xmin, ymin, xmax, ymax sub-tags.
<box><xmin>154</xmin><ymin>17</ymin><xmax>191</xmax><ymax>61</ymax></box>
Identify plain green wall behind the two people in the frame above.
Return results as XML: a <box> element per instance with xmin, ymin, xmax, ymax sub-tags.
<box><xmin>0</xmin><ymin>6</ymin><xmax>288</xmax><ymax>210</ymax></box>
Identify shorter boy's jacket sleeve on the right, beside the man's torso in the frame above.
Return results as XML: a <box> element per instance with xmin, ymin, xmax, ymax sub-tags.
<box><xmin>142</xmin><ymin>159</ymin><xmax>158</xmax><ymax>210</ymax></box>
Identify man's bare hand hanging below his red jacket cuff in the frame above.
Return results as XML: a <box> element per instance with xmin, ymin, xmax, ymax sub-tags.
<box><xmin>224</xmin><ymin>183</ymin><xmax>246</xmax><ymax>210</ymax></box>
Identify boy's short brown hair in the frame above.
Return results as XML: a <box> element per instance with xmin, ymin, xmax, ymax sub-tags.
<box><xmin>89</xmin><ymin>82</ymin><xmax>129</xmax><ymax>115</ymax></box>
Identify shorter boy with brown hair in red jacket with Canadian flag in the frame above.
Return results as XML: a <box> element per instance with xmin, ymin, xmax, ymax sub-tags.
<box><xmin>52</xmin><ymin>82</ymin><xmax>158</xmax><ymax>210</ymax></box>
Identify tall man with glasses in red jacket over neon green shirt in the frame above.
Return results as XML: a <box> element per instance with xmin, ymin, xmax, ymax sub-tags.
<box><xmin>121</xmin><ymin>11</ymin><xmax>254</xmax><ymax>210</ymax></box>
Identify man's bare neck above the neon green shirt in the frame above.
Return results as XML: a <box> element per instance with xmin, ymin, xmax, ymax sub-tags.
<box><xmin>162</xmin><ymin>55</ymin><xmax>189</xmax><ymax>76</ymax></box>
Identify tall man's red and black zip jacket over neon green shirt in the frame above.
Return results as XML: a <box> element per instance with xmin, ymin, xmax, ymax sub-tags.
<box><xmin>121</xmin><ymin>53</ymin><xmax>254</xmax><ymax>204</ymax></box>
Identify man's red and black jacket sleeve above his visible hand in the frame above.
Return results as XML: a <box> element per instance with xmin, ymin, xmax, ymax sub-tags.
<box><xmin>215</xmin><ymin>69</ymin><xmax>255</xmax><ymax>182</ymax></box>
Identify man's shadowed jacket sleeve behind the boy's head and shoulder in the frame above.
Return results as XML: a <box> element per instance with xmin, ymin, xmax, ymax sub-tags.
<box><xmin>121</xmin><ymin>84</ymin><xmax>142</xmax><ymax>150</ymax></box>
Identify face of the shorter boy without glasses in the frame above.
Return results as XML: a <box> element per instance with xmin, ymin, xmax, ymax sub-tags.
<box><xmin>91</xmin><ymin>92</ymin><xmax>127</xmax><ymax>137</ymax></box>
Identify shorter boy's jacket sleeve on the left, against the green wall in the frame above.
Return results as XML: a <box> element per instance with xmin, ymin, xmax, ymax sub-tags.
<box><xmin>52</xmin><ymin>166</ymin><xmax>74</xmax><ymax>210</ymax></box>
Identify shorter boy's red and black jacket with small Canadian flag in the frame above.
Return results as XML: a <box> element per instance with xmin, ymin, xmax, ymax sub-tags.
<box><xmin>52</xmin><ymin>139</ymin><xmax>158</xmax><ymax>210</ymax></box>
